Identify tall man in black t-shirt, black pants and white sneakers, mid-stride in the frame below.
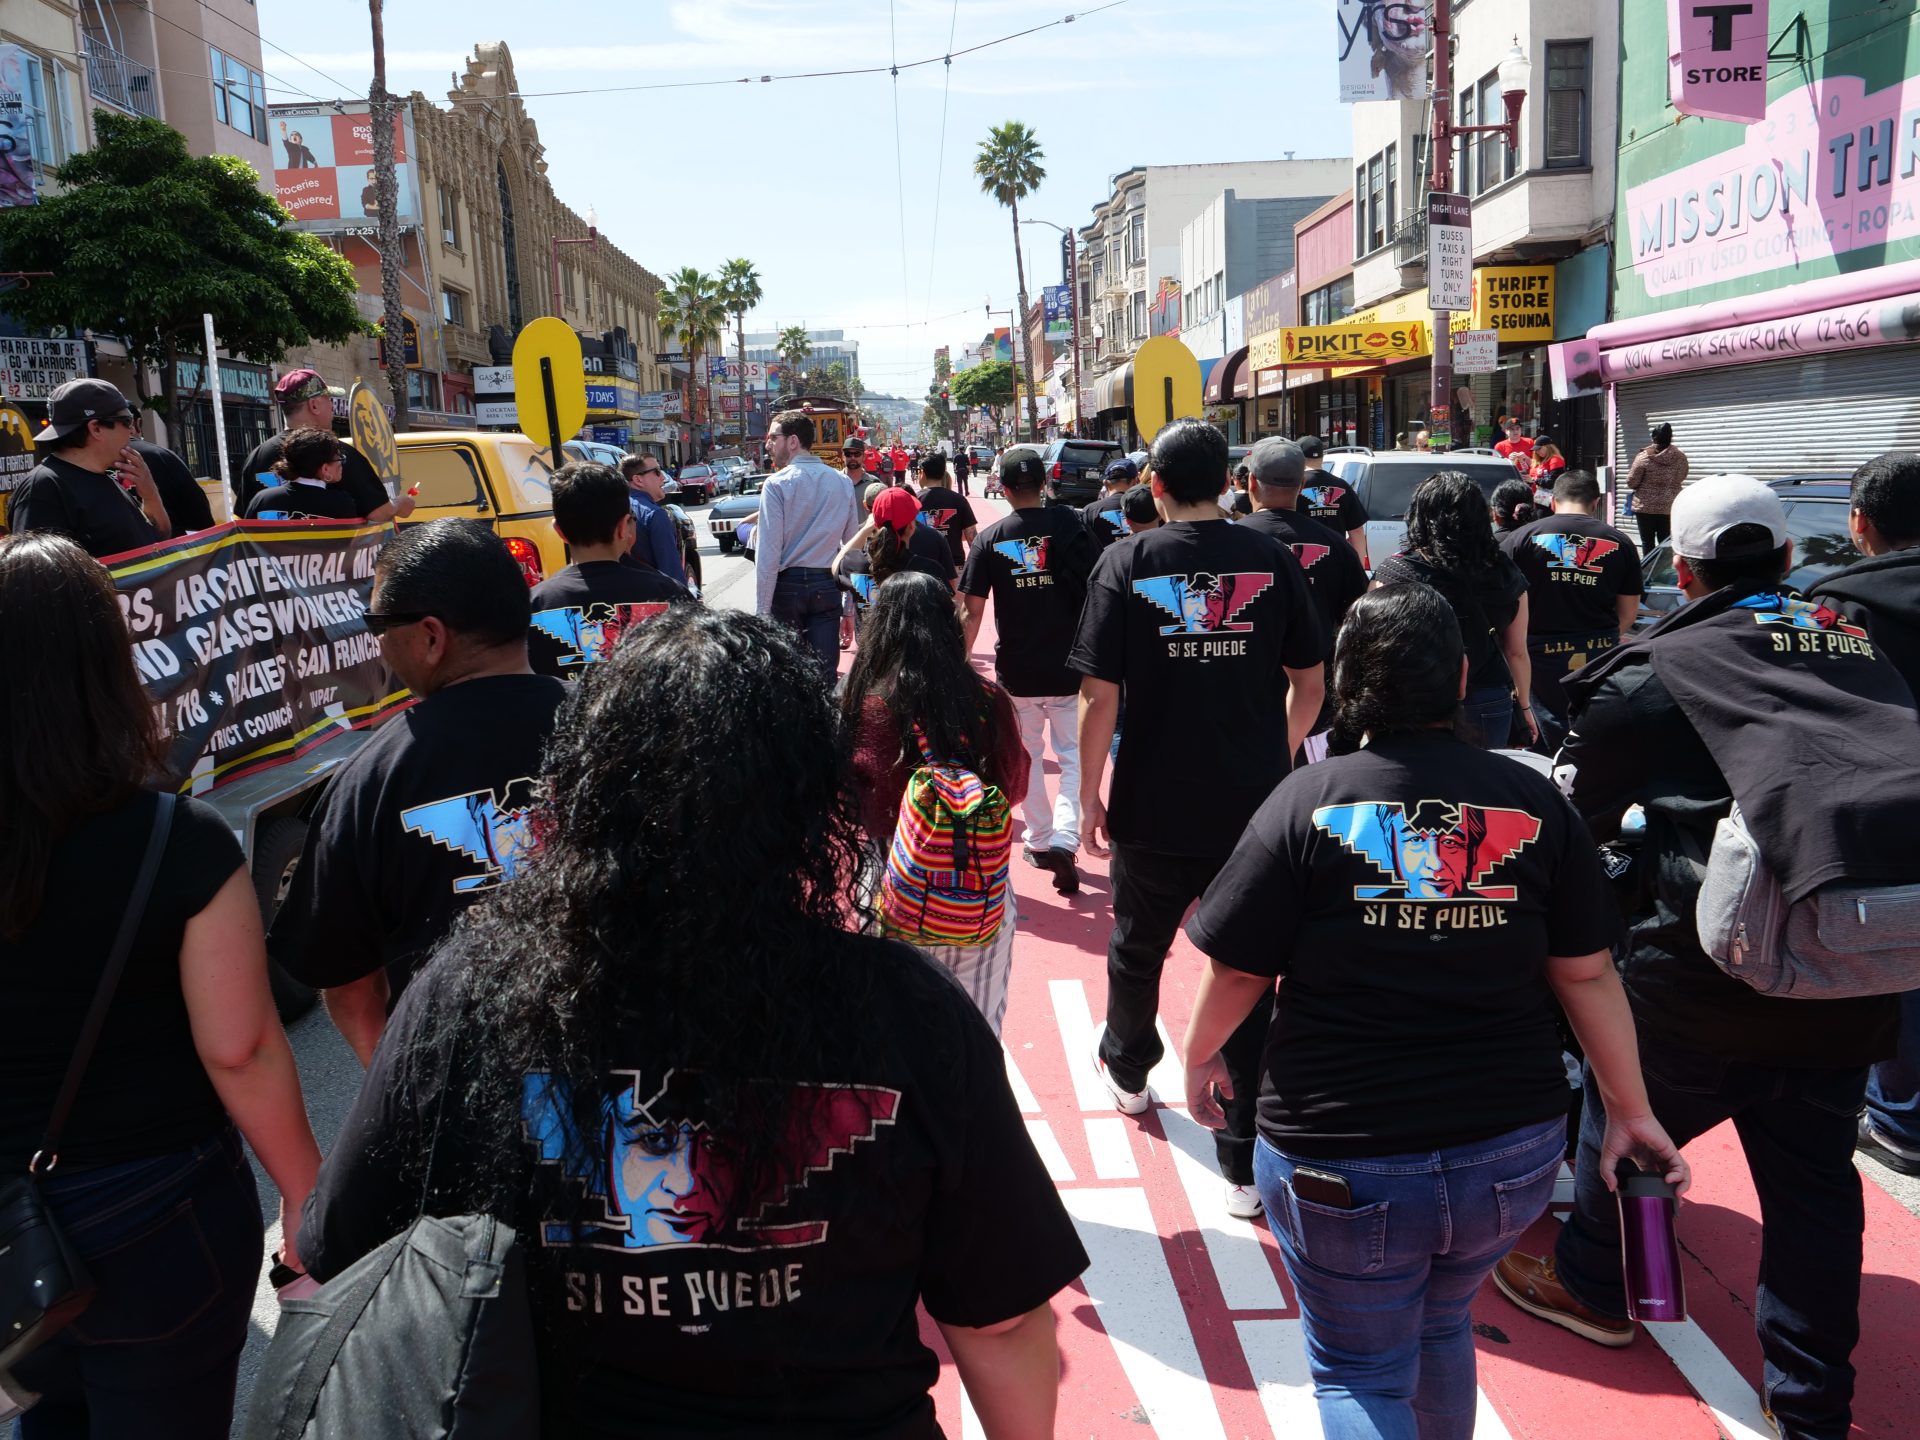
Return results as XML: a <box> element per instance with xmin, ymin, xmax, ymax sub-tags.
<box><xmin>1068</xmin><ymin>420</ymin><xmax>1327</xmax><ymax>1219</ymax></box>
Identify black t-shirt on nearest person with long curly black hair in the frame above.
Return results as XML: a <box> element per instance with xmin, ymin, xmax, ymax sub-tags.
<box><xmin>300</xmin><ymin>935</ymin><xmax>1087</xmax><ymax>1440</ymax></box>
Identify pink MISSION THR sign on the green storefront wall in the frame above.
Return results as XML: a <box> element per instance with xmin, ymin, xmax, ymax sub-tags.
<box><xmin>1622</xmin><ymin>75</ymin><xmax>1920</xmax><ymax>296</ymax></box>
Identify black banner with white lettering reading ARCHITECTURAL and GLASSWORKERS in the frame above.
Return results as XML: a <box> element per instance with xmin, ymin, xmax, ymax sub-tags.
<box><xmin>108</xmin><ymin>520</ymin><xmax>413</xmax><ymax>795</ymax></box>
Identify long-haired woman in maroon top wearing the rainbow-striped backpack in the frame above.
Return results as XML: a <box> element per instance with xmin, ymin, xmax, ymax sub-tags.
<box><xmin>841</xmin><ymin>572</ymin><xmax>1031</xmax><ymax>1035</ymax></box>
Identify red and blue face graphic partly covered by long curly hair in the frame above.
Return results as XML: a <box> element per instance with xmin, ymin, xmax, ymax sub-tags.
<box><xmin>520</xmin><ymin>1069</ymin><xmax>900</xmax><ymax>1252</ymax></box>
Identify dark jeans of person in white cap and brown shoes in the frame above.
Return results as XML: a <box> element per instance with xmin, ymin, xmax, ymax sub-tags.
<box><xmin>1553</xmin><ymin>1052</ymin><xmax>1866</xmax><ymax>1440</ymax></box>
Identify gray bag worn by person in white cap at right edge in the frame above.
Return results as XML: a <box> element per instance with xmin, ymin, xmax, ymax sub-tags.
<box><xmin>1693</xmin><ymin>804</ymin><xmax>1920</xmax><ymax>1000</ymax></box>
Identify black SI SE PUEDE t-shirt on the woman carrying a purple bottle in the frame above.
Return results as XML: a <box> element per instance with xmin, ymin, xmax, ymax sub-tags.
<box><xmin>1190</xmin><ymin>733</ymin><xmax>1620</xmax><ymax>1158</ymax></box>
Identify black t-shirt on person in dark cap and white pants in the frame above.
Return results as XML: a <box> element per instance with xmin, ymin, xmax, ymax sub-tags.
<box><xmin>960</xmin><ymin>505</ymin><xmax>1094</xmax><ymax>695</ymax></box>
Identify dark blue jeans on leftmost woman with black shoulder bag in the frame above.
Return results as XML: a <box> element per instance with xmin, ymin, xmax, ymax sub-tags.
<box><xmin>15</xmin><ymin>1129</ymin><xmax>263</xmax><ymax>1440</ymax></box>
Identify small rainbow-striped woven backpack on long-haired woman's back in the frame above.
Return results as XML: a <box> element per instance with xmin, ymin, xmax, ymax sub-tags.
<box><xmin>876</xmin><ymin>726</ymin><xmax>1014</xmax><ymax>945</ymax></box>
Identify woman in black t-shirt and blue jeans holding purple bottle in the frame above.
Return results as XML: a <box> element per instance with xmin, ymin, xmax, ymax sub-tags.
<box><xmin>1183</xmin><ymin>584</ymin><xmax>1688</xmax><ymax>1440</ymax></box>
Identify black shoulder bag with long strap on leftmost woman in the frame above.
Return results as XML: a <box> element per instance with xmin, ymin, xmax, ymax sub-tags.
<box><xmin>0</xmin><ymin>795</ymin><xmax>177</xmax><ymax>1375</ymax></box>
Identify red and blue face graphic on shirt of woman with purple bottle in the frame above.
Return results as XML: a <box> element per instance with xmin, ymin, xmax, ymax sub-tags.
<box><xmin>1313</xmin><ymin>801</ymin><xmax>1540</xmax><ymax>904</ymax></box>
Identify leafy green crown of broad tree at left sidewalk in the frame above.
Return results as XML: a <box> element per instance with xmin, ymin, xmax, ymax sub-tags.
<box><xmin>0</xmin><ymin>109</ymin><xmax>371</xmax><ymax>417</ymax></box>
